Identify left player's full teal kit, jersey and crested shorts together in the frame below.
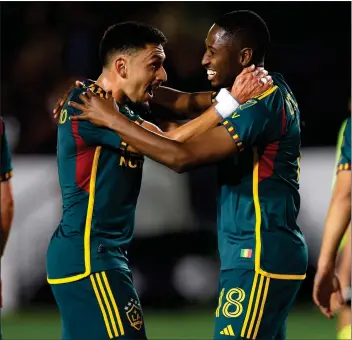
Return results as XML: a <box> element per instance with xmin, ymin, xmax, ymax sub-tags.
<box><xmin>47</xmin><ymin>81</ymin><xmax>146</xmax><ymax>340</ymax></box>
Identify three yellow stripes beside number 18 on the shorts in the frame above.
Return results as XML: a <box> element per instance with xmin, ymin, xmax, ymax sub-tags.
<box><xmin>241</xmin><ymin>273</ymin><xmax>270</xmax><ymax>340</ymax></box>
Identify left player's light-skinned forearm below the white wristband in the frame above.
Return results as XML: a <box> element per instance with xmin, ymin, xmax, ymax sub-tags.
<box><xmin>165</xmin><ymin>105</ymin><xmax>221</xmax><ymax>143</ymax></box>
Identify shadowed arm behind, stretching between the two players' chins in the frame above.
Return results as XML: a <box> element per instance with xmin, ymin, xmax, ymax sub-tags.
<box><xmin>153</xmin><ymin>86</ymin><xmax>212</xmax><ymax>118</ymax></box>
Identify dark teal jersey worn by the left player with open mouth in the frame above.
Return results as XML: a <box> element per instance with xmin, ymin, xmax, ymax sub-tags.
<box><xmin>47</xmin><ymin>82</ymin><xmax>143</xmax><ymax>284</ymax></box>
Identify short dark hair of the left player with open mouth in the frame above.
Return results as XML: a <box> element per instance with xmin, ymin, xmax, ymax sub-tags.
<box><xmin>99</xmin><ymin>21</ymin><xmax>167</xmax><ymax>67</ymax></box>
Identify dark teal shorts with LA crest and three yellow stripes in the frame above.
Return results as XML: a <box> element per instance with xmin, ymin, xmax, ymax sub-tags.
<box><xmin>51</xmin><ymin>269</ymin><xmax>147</xmax><ymax>340</ymax></box>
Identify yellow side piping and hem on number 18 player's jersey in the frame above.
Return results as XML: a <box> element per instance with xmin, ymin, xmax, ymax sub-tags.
<box><xmin>253</xmin><ymin>148</ymin><xmax>306</xmax><ymax>280</ymax></box>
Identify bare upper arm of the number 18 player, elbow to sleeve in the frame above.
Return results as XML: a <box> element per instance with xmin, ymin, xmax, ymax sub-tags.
<box><xmin>181</xmin><ymin>126</ymin><xmax>238</xmax><ymax>171</ymax></box>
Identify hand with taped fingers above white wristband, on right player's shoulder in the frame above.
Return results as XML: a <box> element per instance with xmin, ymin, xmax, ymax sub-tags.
<box><xmin>231</xmin><ymin>65</ymin><xmax>273</xmax><ymax>104</ymax></box>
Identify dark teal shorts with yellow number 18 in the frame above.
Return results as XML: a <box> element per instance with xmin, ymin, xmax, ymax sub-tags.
<box><xmin>214</xmin><ymin>269</ymin><xmax>302</xmax><ymax>340</ymax></box>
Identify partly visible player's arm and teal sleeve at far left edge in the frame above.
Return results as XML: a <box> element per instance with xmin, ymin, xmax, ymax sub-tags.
<box><xmin>0</xmin><ymin>119</ymin><xmax>14</xmax><ymax>257</ymax></box>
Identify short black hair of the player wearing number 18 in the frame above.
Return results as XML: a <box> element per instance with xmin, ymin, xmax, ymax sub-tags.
<box><xmin>215</xmin><ymin>10</ymin><xmax>270</xmax><ymax>62</ymax></box>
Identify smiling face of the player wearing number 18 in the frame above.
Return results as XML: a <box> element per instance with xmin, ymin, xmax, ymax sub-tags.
<box><xmin>202</xmin><ymin>24</ymin><xmax>243</xmax><ymax>88</ymax></box>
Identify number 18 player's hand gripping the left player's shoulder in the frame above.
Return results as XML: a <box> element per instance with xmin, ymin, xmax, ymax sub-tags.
<box><xmin>68</xmin><ymin>90</ymin><xmax>119</xmax><ymax>127</ymax></box>
